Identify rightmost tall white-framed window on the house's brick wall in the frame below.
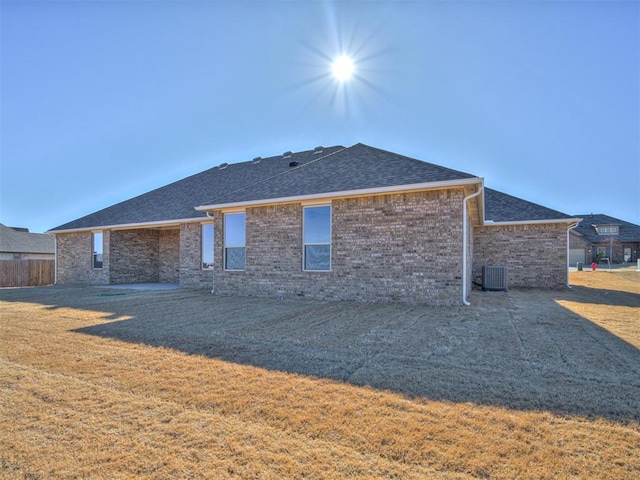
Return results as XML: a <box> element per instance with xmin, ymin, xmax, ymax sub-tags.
<box><xmin>302</xmin><ymin>205</ymin><xmax>331</xmax><ymax>271</ymax></box>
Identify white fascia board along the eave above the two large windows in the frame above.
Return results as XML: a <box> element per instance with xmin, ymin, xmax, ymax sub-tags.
<box><xmin>195</xmin><ymin>177</ymin><xmax>482</xmax><ymax>212</ymax></box>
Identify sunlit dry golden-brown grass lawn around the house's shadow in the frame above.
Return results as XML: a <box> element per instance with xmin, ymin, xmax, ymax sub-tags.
<box><xmin>0</xmin><ymin>271</ymin><xmax>640</xmax><ymax>479</ymax></box>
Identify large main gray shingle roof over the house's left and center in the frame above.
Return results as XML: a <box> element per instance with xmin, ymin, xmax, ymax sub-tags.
<box><xmin>52</xmin><ymin>144</ymin><xmax>474</xmax><ymax>231</ymax></box>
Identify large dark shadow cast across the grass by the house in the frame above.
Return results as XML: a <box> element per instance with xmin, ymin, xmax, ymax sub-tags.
<box><xmin>0</xmin><ymin>287</ymin><xmax>640</xmax><ymax>422</ymax></box>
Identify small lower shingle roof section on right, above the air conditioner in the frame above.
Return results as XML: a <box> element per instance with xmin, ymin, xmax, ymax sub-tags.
<box><xmin>484</xmin><ymin>187</ymin><xmax>573</xmax><ymax>222</ymax></box>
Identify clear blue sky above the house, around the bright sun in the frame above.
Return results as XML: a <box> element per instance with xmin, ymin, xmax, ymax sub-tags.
<box><xmin>0</xmin><ymin>0</ymin><xmax>640</xmax><ymax>232</ymax></box>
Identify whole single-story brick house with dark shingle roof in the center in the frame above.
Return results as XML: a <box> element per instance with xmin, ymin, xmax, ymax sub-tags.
<box><xmin>51</xmin><ymin>144</ymin><xmax>579</xmax><ymax>305</ymax></box>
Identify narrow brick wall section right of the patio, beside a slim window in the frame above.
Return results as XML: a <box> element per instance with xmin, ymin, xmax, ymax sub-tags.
<box><xmin>179</xmin><ymin>223</ymin><xmax>214</xmax><ymax>289</ymax></box>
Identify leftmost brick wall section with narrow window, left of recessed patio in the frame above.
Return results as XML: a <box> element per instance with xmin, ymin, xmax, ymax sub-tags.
<box><xmin>56</xmin><ymin>231</ymin><xmax>111</xmax><ymax>285</ymax></box>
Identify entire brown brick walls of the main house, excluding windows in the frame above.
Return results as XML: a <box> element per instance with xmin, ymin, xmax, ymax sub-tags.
<box><xmin>56</xmin><ymin>189</ymin><xmax>567</xmax><ymax>298</ymax></box>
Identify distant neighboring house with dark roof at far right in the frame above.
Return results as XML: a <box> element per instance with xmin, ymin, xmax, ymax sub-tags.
<box><xmin>569</xmin><ymin>213</ymin><xmax>640</xmax><ymax>265</ymax></box>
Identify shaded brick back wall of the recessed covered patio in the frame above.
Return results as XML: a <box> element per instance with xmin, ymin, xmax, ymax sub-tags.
<box><xmin>109</xmin><ymin>228</ymin><xmax>160</xmax><ymax>285</ymax></box>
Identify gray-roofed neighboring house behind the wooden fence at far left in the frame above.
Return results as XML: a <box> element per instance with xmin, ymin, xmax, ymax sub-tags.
<box><xmin>0</xmin><ymin>223</ymin><xmax>56</xmax><ymax>260</ymax></box>
